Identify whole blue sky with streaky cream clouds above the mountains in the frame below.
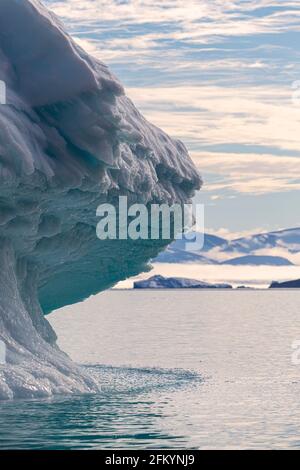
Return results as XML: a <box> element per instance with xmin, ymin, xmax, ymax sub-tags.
<box><xmin>44</xmin><ymin>0</ymin><xmax>300</xmax><ymax>238</ymax></box>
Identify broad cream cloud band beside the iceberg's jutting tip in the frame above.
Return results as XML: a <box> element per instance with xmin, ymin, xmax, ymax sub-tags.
<box><xmin>128</xmin><ymin>86</ymin><xmax>300</xmax><ymax>194</ymax></box>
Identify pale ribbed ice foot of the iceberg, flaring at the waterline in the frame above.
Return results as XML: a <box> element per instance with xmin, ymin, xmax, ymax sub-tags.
<box><xmin>0</xmin><ymin>243</ymin><xmax>99</xmax><ymax>399</ymax></box>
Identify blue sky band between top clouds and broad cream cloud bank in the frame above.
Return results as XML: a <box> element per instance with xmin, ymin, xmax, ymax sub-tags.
<box><xmin>96</xmin><ymin>31</ymin><xmax>300</xmax><ymax>87</ymax></box>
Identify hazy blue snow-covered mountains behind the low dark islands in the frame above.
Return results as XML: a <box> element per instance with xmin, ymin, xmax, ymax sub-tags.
<box><xmin>154</xmin><ymin>228</ymin><xmax>300</xmax><ymax>266</ymax></box>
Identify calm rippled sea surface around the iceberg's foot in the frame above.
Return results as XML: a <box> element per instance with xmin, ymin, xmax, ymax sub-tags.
<box><xmin>0</xmin><ymin>290</ymin><xmax>300</xmax><ymax>449</ymax></box>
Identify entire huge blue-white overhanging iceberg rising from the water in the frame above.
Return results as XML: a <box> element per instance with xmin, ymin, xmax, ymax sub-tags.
<box><xmin>0</xmin><ymin>0</ymin><xmax>201</xmax><ymax>398</ymax></box>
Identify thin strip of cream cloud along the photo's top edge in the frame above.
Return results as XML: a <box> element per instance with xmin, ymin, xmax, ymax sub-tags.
<box><xmin>46</xmin><ymin>0</ymin><xmax>299</xmax><ymax>31</ymax></box>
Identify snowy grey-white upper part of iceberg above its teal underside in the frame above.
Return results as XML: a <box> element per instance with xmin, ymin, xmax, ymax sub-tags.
<box><xmin>0</xmin><ymin>0</ymin><xmax>200</xmax><ymax>195</ymax></box>
